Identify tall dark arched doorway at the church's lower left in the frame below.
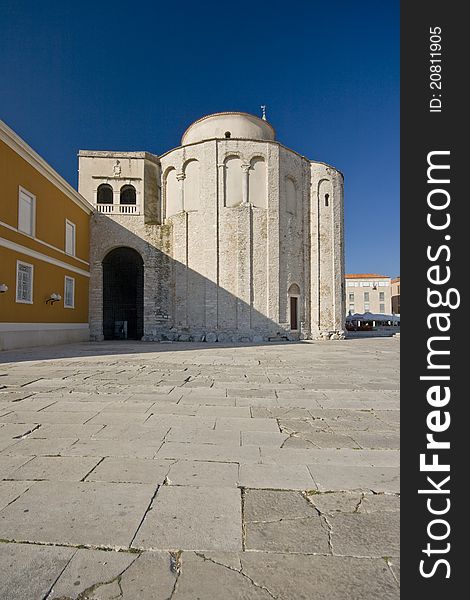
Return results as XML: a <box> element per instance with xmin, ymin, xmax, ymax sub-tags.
<box><xmin>103</xmin><ymin>248</ymin><xmax>144</xmax><ymax>340</ymax></box>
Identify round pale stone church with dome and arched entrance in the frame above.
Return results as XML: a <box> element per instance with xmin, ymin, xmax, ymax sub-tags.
<box><xmin>79</xmin><ymin>112</ymin><xmax>345</xmax><ymax>342</ymax></box>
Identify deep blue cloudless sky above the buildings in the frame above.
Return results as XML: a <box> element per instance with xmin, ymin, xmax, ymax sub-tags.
<box><xmin>0</xmin><ymin>0</ymin><xmax>399</xmax><ymax>276</ymax></box>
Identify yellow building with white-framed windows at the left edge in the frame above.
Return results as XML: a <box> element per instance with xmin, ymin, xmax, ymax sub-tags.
<box><xmin>0</xmin><ymin>121</ymin><xmax>93</xmax><ymax>350</ymax></box>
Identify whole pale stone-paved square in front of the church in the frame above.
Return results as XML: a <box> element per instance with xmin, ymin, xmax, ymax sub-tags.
<box><xmin>0</xmin><ymin>338</ymin><xmax>399</xmax><ymax>600</ymax></box>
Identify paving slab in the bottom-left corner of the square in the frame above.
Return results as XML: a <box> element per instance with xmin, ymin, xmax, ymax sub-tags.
<box><xmin>0</xmin><ymin>544</ymin><xmax>76</xmax><ymax>600</ymax></box>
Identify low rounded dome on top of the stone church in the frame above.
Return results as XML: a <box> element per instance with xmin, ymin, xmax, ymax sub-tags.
<box><xmin>181</xmin><ymin>112</ymin><xmax>275</xmax><ymax>146</ymax></box>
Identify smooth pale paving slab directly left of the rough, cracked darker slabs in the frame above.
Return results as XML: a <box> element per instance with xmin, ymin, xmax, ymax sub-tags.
<box><xmin>132</xmin><ymin>486</ymin><xmax>242</xmax><ymax>551</ymax></box>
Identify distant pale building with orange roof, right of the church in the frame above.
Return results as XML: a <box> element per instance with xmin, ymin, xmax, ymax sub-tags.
<box><xmin>345</xmin><ymin>273</ymin><xmax>392</xmax><ymax>315</ymax></box>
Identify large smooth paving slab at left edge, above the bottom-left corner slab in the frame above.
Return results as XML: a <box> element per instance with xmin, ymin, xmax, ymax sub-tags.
<box><xmin>0</xmin><ymin>481</ymin><xmax>155</xmax><ymax>548</ymax></box>
